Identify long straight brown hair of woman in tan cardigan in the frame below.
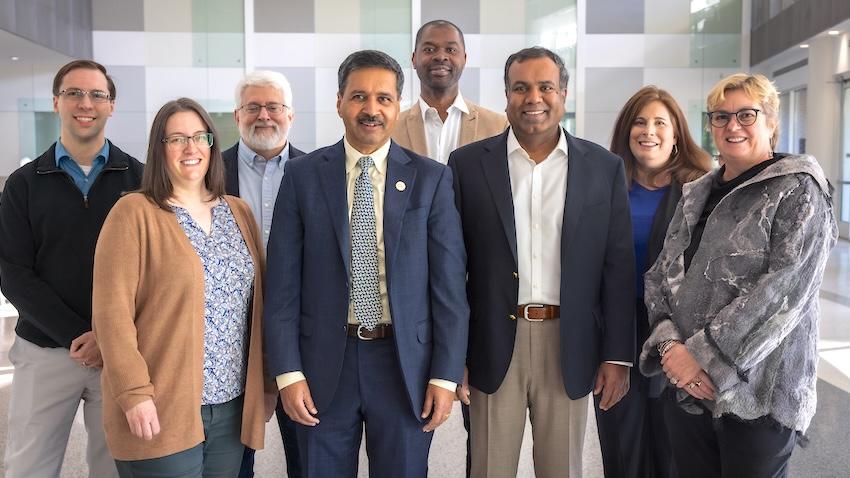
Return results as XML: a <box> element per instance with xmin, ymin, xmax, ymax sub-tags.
<box><xmin>139</xmin><ymin>98</ymin><xmax>224</xmax><ymax>211</ymax></box>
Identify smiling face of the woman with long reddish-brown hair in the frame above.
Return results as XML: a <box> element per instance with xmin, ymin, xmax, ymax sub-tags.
<box><xmin>629</xmin><ymin>101</ymin><xmax>676</xmax><ymax>177</ymax></box>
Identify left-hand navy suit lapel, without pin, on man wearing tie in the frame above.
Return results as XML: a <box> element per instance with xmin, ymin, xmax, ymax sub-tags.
<box><xmin>318</xmin><ymin>140</ymin><xmax>351</xmax><ymax>273</ymax></box>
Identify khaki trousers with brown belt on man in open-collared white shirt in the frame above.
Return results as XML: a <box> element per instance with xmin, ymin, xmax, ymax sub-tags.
<box><xmin>470</xmin><ymin>319</ymin><xmax>588</xmax><ymax>478</ymax></box>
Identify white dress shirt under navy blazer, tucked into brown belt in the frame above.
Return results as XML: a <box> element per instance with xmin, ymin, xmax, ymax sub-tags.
<box><xmin>508</xmin><ymin>128</ymin><xmax>632</xmax><ymax>367</ymax></box>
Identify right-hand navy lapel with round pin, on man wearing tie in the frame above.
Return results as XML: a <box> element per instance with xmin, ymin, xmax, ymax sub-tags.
<box><xmin>384</xmin><ymin>142</ymin><xmax>416</xmax><ymax>274</ymax></box>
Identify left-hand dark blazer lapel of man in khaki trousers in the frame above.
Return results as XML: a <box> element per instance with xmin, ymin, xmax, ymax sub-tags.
<box><xmin>479</xmin><ymin>131</ymin><xmax>519</xmax><ymax>266</ymax></box>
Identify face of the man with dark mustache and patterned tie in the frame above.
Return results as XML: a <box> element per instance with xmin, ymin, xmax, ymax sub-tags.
<box><xmin>336</xmin><ymin>68</ymin><xmax>399</xmax><ymax>154</ymax></box>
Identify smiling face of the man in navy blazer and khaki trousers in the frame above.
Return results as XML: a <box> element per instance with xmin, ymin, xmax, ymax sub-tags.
<box><xmin>505</xmin><ymin>58</ymin><xmax>567</xmax><ymax>142</ymax></box>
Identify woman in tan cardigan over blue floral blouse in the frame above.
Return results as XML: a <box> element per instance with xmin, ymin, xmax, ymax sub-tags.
<box><xmin>92</xmin><ymin>98</ymin><xmax>273</xmax><ymax>477</ymax></box>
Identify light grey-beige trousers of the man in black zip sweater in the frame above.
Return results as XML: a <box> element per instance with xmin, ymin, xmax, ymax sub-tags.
<box><xmin>6</xmin><ymin>336</ymin><xmax>118</xmax><ymax>478</ymax></box>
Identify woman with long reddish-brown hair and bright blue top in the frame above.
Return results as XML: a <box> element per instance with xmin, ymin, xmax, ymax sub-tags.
<box><xmin>596</xmin><ymin>86</ymin><xmax>711</xmax><ymax>478</ymax></box>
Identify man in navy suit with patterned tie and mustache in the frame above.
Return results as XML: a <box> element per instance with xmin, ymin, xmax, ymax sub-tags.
<box><xmin>264</xmin><ymin>50</ymin><xmax>469</xmax><ymax>477</ymax></box>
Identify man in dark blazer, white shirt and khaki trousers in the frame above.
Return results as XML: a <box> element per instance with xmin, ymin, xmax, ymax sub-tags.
<box><xmin>449</xmin><ymin>47</ymin><xmax>635</xmax><ymax>478</ymax></box>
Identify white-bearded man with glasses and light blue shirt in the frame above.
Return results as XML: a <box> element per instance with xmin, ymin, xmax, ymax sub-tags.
<box><xmin>221</xmin><ymin>70</ymin><xmax>304</xmax><ymax>478</ymax></box>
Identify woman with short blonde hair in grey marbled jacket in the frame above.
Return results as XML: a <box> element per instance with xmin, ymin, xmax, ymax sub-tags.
<box><xmin>640</xmin><ymin>73</ymin><xmax>838</xmax><ymax>478</ymax></box>
